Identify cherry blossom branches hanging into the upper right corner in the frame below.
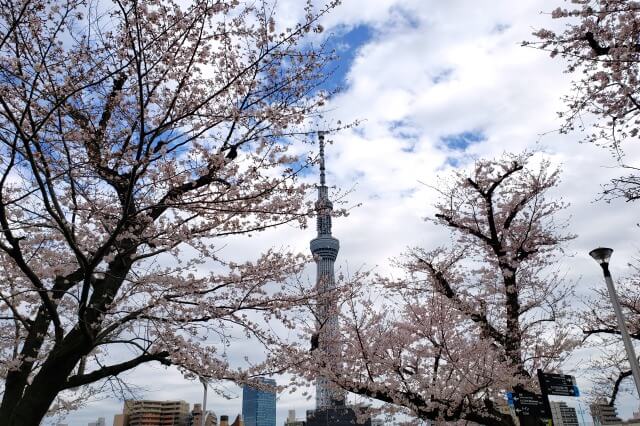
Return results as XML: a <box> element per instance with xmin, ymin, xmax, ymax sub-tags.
<box><xmin>524</xmin><ymin>0</ymin><xmax>640</xmax><ymax>201</ymax></box>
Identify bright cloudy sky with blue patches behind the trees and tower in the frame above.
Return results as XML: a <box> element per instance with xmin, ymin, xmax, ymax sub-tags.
<box><xmin>57</xmin><ymin>0</ymin><xmax>640</xmax><ymax>426</ymax></box>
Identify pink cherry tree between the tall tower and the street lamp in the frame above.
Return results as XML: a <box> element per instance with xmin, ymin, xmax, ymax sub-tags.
<box><xmin>292</xmin><ymin>153</ymin><xmax>576</xmax><ymax>425</ymax></box>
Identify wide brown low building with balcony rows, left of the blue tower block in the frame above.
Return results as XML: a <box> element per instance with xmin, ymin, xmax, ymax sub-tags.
<box><xmin>114</xmin><ymin>400</ymin><xmax>191</xmax><ymax>426</ymax></box>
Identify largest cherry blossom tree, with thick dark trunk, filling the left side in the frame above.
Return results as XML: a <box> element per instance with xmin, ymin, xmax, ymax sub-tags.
<box><xmin>0</xmin><ymin>0</ymin><xmax>337</xmax><ymax>426</ymax></box>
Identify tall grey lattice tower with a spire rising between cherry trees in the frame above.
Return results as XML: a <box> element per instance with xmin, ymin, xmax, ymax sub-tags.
<box><xmin>310</xmin><ymin>133</ymin><xmax>344</xmax><ymax>409</ymax></box>
